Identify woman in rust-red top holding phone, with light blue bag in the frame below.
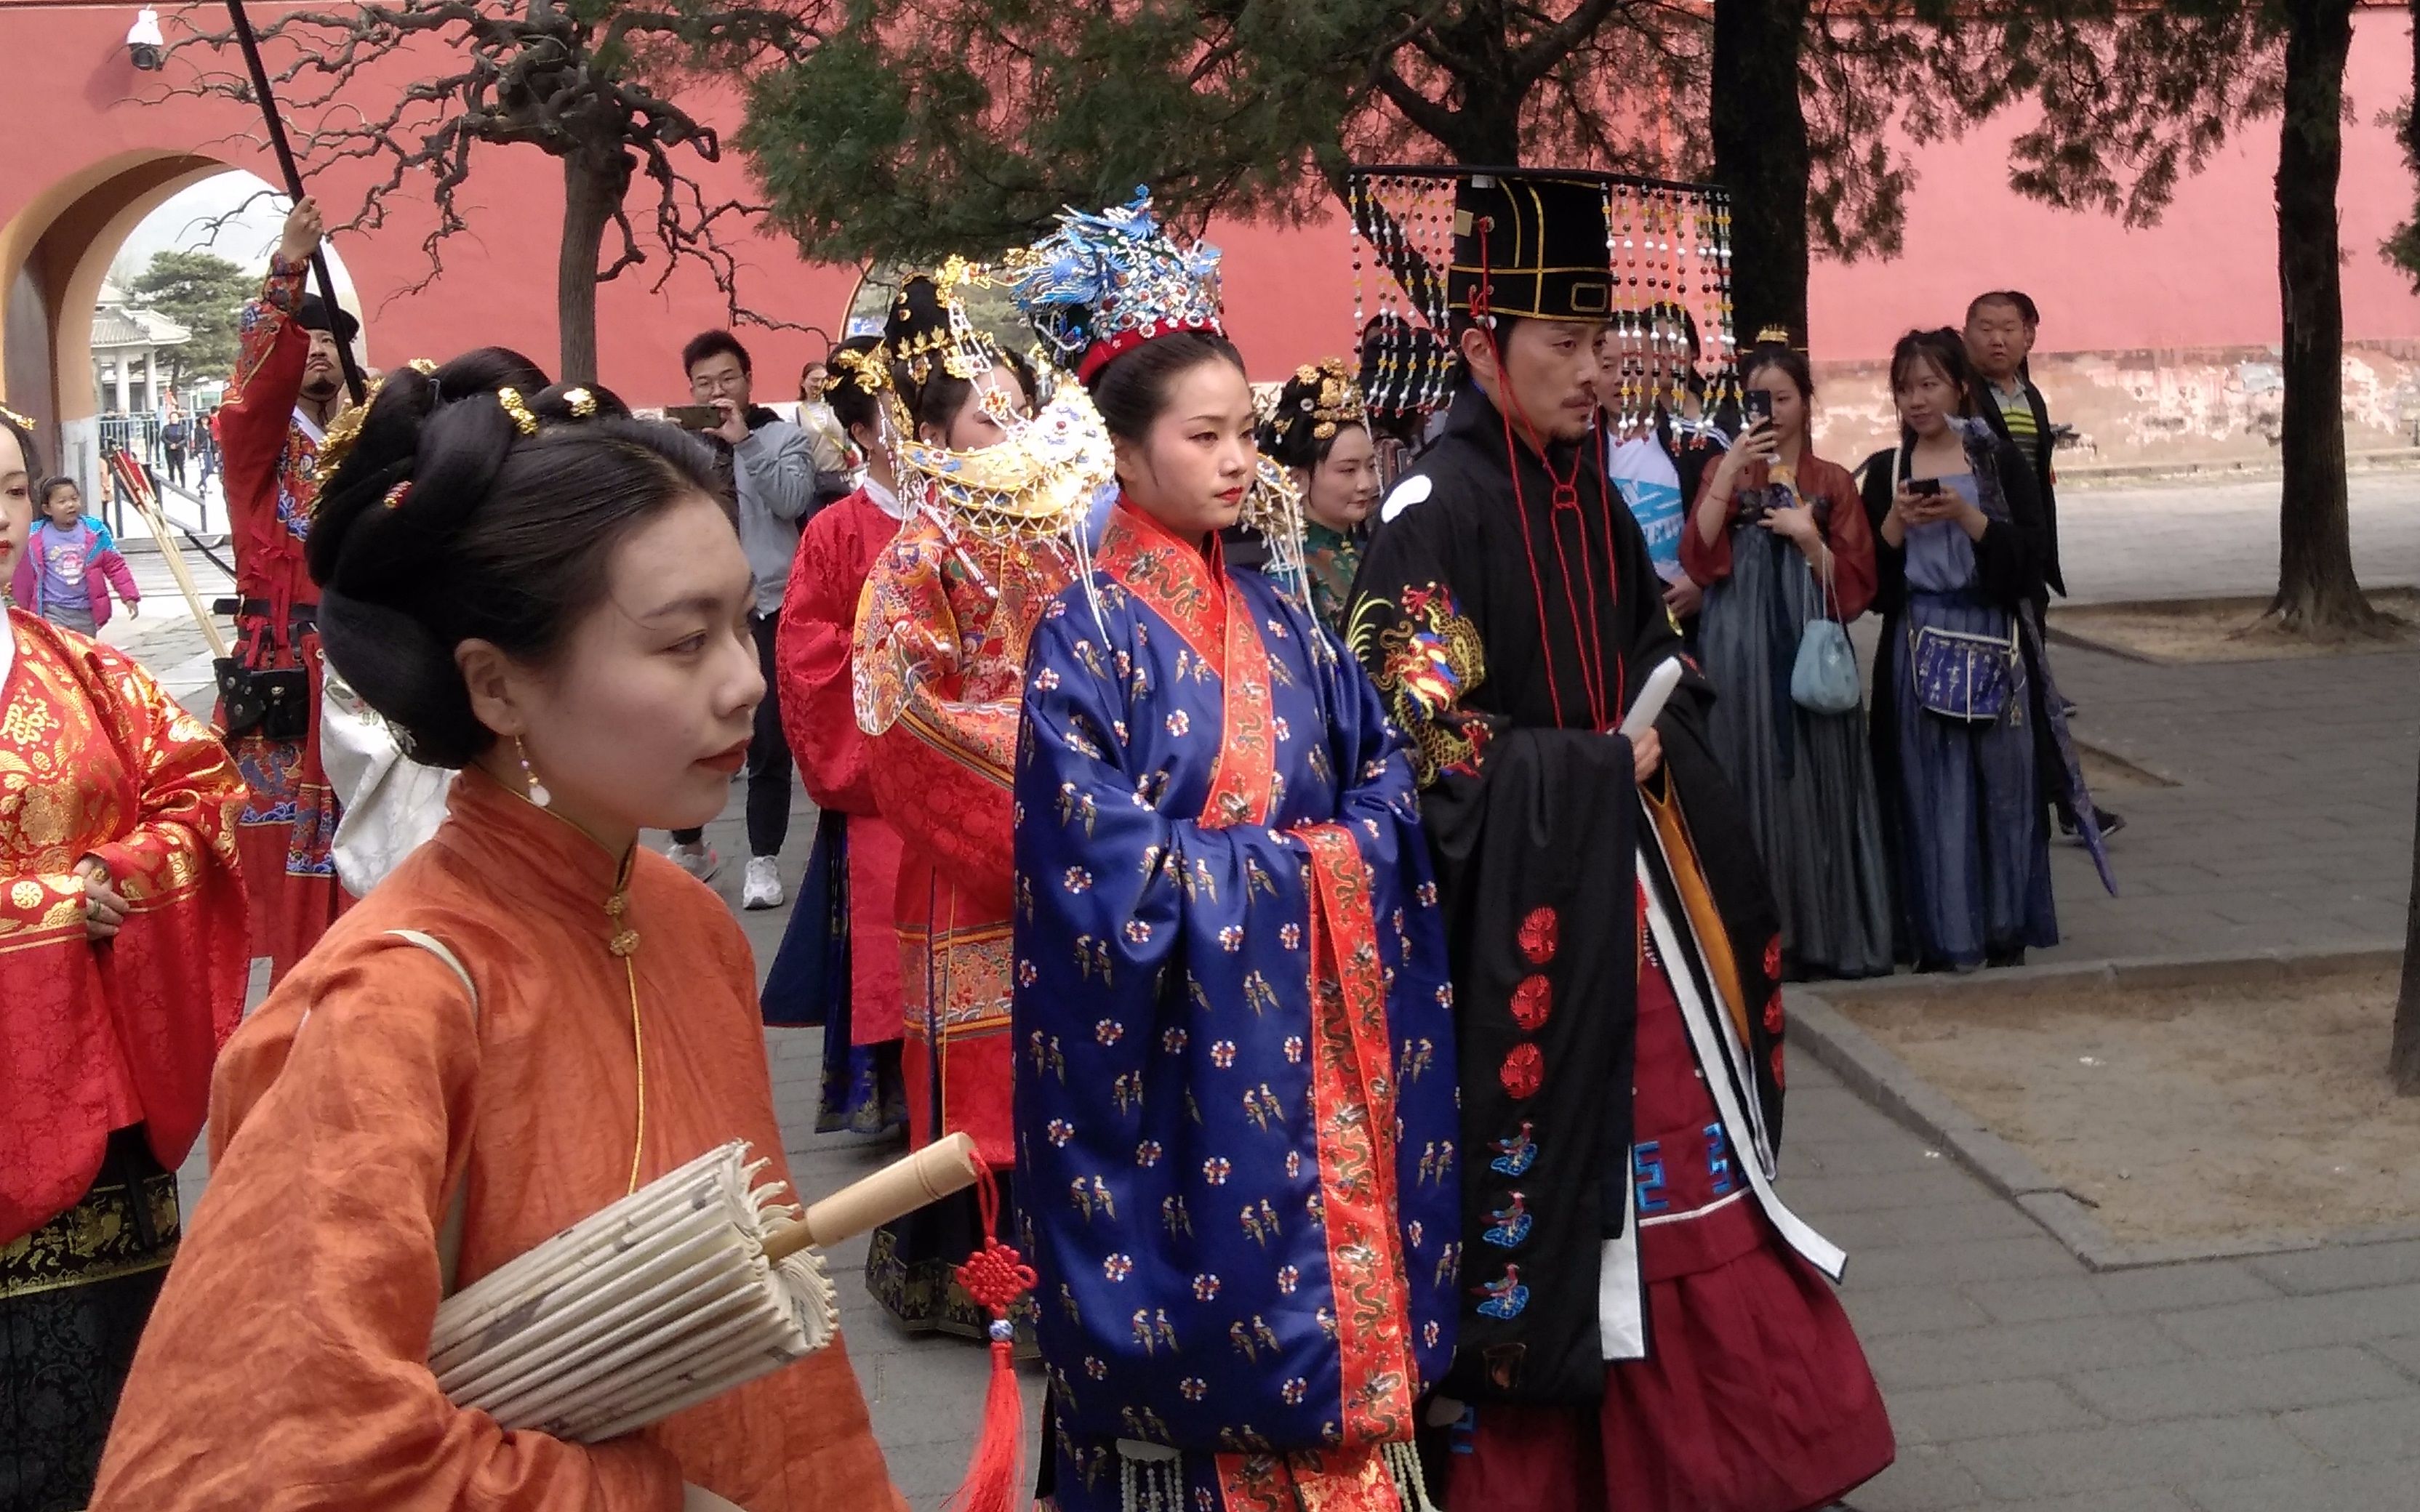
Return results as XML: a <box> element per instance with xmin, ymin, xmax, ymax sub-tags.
<box><xmin>1680</xmin><ymin>344</ymin><xmax>1892</xmax><ymax>980</ymax></box>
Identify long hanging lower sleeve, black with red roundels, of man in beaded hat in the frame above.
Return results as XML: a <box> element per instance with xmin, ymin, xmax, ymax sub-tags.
<box><xmin>1423</xmin><ymin>731</ymin><xmax>1638</xmax><ymax>1403</ymax></box>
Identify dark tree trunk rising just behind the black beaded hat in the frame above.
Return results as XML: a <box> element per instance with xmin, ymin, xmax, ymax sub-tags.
<box><xmin>1711</xmin><ymin>0</ymin><xmax>1810</xmax><ymax>346</ymax></box>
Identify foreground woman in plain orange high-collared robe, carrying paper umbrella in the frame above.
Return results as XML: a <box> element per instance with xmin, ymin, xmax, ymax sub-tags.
<box><xmin>92</xmin><ymin>348</ymin><xmax>902</xmax><ymax>1512</ymax></box>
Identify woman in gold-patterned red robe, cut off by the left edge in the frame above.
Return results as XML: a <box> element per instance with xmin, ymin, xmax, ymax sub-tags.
<box><xmin>0</xmin><ymin>411</ymin><xmax>247</xmax><ymax>1512</ymax></box>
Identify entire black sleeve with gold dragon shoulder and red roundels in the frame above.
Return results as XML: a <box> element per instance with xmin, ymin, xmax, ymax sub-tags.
<box><xmin>1348</xmin><ymin>496</ymin><xmax>1646</xmax><ymax>1403</ymax></box>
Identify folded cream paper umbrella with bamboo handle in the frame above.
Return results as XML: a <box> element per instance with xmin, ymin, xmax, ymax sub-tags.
<box><xmin>428</xmin><ymin>1135</ymin><xmax>978</xmax><ymax>1444</ymax></box>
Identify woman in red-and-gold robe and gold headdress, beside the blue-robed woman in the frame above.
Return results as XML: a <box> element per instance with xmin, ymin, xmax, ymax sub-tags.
<box><xmin>852</xmin><ymin>278</ymin><xmax>1077</xmax><ymax>1340</ymax></box>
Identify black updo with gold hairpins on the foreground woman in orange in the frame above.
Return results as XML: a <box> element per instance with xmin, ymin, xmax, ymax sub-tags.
<box><xmin>305</xmin><ymin>346</ymin><xmax>718</xmax><ymax>767</ymax></box>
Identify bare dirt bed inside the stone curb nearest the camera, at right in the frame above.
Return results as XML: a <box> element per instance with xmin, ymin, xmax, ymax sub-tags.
<box><xmin>1832</xmin><ymin>968</ymin><xmax>2420</xmax><ymax>1244</ymax></box>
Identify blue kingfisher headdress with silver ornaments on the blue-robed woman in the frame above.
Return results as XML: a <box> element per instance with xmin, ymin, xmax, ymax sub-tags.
<box><xmin>997</xmin><ymin>189</ymin><xmax>1225</xmax><ymax>382</ymax></box>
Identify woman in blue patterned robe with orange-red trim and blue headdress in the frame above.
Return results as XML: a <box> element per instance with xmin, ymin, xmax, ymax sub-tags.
<box><xmin>1009</xmin><ymin>198</ymin><xmax>1459</xmax><ymax>1512</ymax></box>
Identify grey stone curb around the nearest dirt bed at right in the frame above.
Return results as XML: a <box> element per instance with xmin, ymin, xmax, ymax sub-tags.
<box><xmin>1784</xmin><ymin>944</ymin><xmax>2420</xmax><ymax>1270</ymax></box>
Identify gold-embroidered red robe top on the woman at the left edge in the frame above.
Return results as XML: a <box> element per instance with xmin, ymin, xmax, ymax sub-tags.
<box><xmin>0</xmin><ymin>610</ymin><xmax>244</xmax><ymax>1244</ymax></box>
